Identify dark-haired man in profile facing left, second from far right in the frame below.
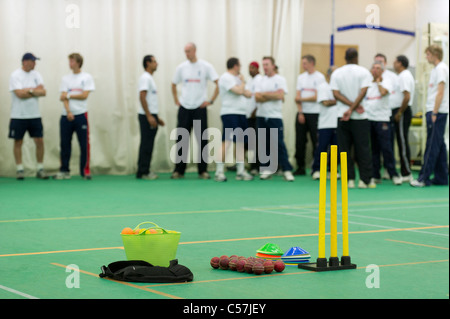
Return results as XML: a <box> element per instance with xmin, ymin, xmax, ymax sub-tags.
<box><xmin>392</xmin><ymin>55</ymin><xmax>415</xmax><ymax>182</ymax></box>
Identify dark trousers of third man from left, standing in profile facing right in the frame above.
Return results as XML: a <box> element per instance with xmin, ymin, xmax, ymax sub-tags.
<box><xmin>136</xmin><ymin>114</ymin><xmax>158</xmax><ymax>178</ymax></box>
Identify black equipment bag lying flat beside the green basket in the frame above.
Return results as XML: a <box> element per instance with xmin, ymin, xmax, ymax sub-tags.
<box><xmin>99</xmin><ymin>259</ymin><xmax>194</xmax><ymax>283</ymax></box>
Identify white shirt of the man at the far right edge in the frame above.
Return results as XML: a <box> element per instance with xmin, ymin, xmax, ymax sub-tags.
<box><xmin>427</xmin><ymin>62</ymin><xmax>448</xmax><ymax>113</ymax></box>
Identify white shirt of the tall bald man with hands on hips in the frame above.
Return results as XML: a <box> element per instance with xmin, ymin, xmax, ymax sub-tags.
<box><xmin>172</xmin><ymin>59</ymin><xmax>219</xmax><ymax>110</ymax></box>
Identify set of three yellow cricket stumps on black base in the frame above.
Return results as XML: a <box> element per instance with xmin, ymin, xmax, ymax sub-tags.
<box><xmin>298</xmin><ymin>145</ymin><xmax>356</xmax><ymax>271</ymax></box>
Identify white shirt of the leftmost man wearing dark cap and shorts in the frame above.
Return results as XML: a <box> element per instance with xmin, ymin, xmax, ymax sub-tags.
<box><xmin>9</xmin><ymin>68</ymin><xmax>44</xmax><ymax>119</ymax></box>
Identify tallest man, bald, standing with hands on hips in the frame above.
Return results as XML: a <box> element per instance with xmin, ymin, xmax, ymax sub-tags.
<box><xmin>171</xmin><ymin>43</ymin><xmax>219</xmax><ymax>179</ymax></box>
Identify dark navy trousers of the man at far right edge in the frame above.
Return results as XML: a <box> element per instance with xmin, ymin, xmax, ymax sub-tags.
<box><xmin>418</xmin><ymin>112</ymin><xmax>448</xmax><ymax>185</ymax></box>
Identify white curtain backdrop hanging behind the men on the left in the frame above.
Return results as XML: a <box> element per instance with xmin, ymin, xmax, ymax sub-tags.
<box><xmin>0</xmin><ymin>0</ymin><xmax>303</xmax><ymax>176</ymax></box>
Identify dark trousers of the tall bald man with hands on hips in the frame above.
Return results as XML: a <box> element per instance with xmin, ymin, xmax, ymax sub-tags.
<box><xmin>174</xmin><ymin>105</ymin><xmax>208</xmax><ymax>175</ymax></box>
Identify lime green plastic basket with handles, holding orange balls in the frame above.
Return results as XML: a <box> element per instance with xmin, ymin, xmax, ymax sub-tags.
<box><xmin>121</xmin><ymin>222</ymin><xmax>181</xmax><ymax>267</ymax></box>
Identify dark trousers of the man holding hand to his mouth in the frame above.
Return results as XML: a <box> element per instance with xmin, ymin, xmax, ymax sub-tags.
<box><xmin>369</xmin><ymin>121</ymin><xmax>398</xmax><ymax>179</ymax></box>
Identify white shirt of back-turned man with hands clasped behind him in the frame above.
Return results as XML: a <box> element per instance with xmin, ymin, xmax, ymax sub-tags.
<box><xmin>330</xmin><ymin>64</ymin><xmax>373</xmax><ymax>120</ymax></box>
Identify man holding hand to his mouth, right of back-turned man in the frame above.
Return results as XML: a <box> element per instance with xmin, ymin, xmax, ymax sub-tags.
<box><xmin>362</xmin><ymin>61</ymin><xmax>402</xmax><ymax>185</ymax></box>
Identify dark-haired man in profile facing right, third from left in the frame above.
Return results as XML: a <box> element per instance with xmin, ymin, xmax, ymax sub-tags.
<box><xmin>136</xmin><ymin>55</ymin><xmax>164</xmax><ymax>180</ymax></box>
